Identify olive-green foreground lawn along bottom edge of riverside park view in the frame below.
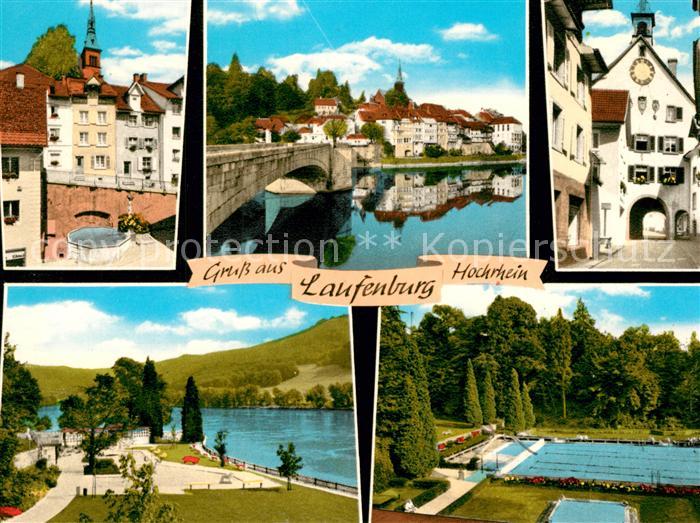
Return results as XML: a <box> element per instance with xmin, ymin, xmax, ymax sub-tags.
<box><xmin>51</xmin><ymin>485</ymin><xmax>358</xmax><ymax>523</ymax></box>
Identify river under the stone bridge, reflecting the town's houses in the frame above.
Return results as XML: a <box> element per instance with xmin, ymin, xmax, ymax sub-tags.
<box><xmin>212</xmin><ymin>164</ymin><xmax>527</xmax><ymax>270</ymax></box>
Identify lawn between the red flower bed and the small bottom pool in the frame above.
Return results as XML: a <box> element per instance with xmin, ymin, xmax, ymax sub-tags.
<box><xmin>443</xmin><ymin>480</ymin><xmax>700</xmax><ymax>523</ymax></box>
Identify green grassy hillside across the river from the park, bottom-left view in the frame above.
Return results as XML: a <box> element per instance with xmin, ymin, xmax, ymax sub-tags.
<box><xmin>27</xmin><ymin>316</ymin><xmax>352</xmax><ymax>405</ymax></box>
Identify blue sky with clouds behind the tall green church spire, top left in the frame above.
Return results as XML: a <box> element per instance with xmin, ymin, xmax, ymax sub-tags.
<box><xmin>0</xmin><ymin>0</ymin><xmax>189</xmax><ymax>84</ymax></box>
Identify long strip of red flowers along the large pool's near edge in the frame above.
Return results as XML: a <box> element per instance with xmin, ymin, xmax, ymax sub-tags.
<box><xmin>494</xmin><ymin>476</ymin><xmax>700</xmax><ymax>496</ymax></box>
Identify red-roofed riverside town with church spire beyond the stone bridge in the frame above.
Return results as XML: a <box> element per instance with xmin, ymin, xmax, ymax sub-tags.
<box><xmin>255</xmin><ymin>65</ymin><xmax>525</xmax><ymax>158</ymax></box>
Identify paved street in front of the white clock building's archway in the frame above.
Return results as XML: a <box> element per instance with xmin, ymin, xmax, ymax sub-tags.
<box><xmin>565</xmin><ymin>237</ymin><xmax>700</xmax><ymax>270</ymax></box>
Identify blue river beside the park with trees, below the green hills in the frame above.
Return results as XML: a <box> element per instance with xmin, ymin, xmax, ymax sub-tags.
<box><xmin>39</xmin><ymin>405</ymin><xmax>357</xmax><ymax>486</ymax></box>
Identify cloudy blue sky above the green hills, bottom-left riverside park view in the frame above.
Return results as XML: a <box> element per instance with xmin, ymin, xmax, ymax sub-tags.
<box><xmin>3</xmin><ymin>285</ymin><xmax>347</xmax><ymax>368</ymax></box>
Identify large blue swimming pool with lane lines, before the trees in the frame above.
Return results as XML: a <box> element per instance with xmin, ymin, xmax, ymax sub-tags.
<box><xmin>510</xmin><ymin>442</ymin><xmax>700</xmax><ymax>486</ymax></box>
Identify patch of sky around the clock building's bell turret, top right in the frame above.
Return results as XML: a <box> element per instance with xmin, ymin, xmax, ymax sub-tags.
<box><xmin>584</xmin><ymin>0</ymin><xmax>700</xmax><ymax>92</ymax></box>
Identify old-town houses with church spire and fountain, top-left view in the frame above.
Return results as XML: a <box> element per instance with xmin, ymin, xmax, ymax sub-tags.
<box><xmin>0</xmin><ymin>2</ymin><xmax>184</xmax><ymax>267</ymax></box>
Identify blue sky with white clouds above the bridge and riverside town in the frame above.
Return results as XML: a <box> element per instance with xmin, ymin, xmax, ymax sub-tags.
<box><xmin>207</xmin><ymin>0</ymin><xmax>527</xmax><ymax>121</ymax></box>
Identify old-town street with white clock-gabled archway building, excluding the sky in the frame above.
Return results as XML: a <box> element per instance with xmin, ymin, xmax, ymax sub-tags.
<box><xmin>545</xmin><ymin>0</ymin><xmax>700</xmax><ymax>269</ymax></box>
